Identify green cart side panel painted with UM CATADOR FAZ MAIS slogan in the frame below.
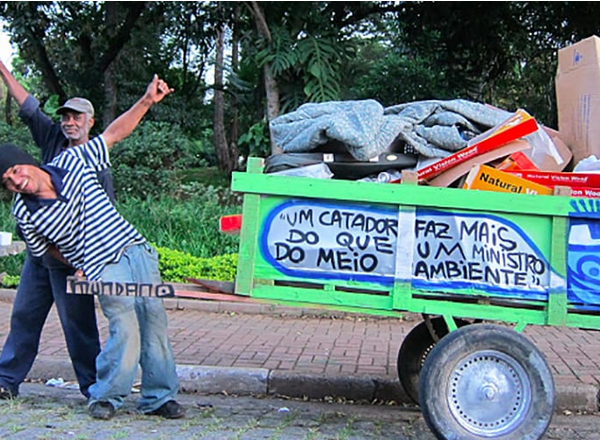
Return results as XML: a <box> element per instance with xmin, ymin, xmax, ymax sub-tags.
<box><xmin>242</xmin><ymin>196</ymin><xmax>563</xmax><ymax>316</ymax></box>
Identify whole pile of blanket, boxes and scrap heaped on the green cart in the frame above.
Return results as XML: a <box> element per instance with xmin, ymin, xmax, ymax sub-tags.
<box><xmin>264</xmin><ymin>36</ymin><xmax>600</xmax><ymax>198</ymax></box>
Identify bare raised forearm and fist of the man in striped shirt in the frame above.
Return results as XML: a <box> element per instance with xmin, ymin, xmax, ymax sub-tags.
<box><xmin>102</xmin><ymin>75</ymin><xmax>173</xmax><ymax>148</ymax></box>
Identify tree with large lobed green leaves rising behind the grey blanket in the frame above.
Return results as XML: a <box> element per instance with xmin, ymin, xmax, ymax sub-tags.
<box><xmin>239</xmin><ymin>2</ymin><xmax>404</xmax><ymax>154</ymax></box>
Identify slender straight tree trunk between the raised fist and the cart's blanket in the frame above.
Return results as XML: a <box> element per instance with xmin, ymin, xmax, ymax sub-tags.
<box><xmin>213</xmin><ymin>18</ymin><xmax>233</xmax><ymax>173</ymax></box>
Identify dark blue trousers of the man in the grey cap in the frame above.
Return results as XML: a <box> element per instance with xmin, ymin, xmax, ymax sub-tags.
<box><xmin>0</xmin><ymin>253</ymin><xmax>100</xmax><ymax>397</ymax></box>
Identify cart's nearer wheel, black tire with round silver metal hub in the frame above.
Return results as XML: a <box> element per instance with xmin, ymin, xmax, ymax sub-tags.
<box><xmin>419</xmin><ymin>324</ymin><xmax>554</xmax><ymax>440</ymax></box>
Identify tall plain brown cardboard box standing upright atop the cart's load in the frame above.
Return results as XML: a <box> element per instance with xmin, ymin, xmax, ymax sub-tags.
<box><xmin>555</xmin><ymin>36</ymin><xmax>600</xmax><ymax>165</ymax></box>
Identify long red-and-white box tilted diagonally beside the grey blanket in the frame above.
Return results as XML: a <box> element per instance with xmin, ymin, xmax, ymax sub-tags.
<box><xmin>417</xmin><ymin>109</ymin><xmax>538</xmax><ymax>181</ymax></box>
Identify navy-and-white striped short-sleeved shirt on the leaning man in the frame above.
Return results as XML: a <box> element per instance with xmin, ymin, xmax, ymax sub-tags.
<box><xmin>13</xmin><ymin>136</ymin><xmax>145</xmax><ymax>280</ymax></box>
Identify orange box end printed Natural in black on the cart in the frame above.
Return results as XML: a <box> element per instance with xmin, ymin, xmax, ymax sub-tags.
<box><xmin>463</xmin><ymin>165</ymin><xmax>553</xmax><ymax>195</ymax></box>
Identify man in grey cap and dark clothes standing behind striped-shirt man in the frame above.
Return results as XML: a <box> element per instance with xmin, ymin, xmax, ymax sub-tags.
<box><xmin>0</xmin><ymin>61</ymin><xmax>103</xmax><ymax>399</ymax></box>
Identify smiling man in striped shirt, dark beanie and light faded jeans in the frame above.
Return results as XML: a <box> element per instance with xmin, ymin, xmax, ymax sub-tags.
<box><xmin>0</xmin><ymin>75</ymin><xmax>185</xmax><ymax>419</ymax></box>
